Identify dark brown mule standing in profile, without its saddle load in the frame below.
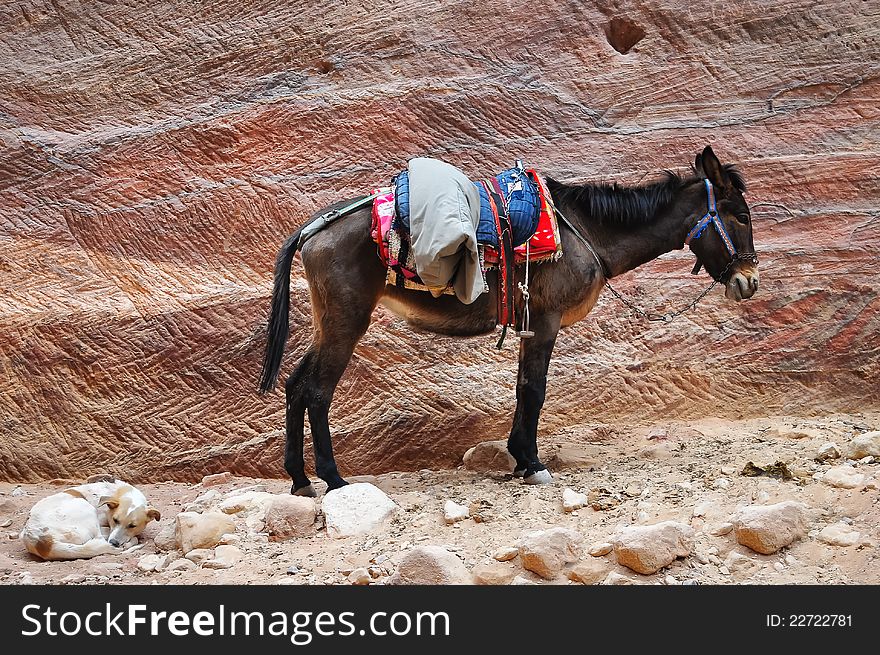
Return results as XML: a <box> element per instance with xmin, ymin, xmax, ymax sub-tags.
<box><xmin>260</xmin><ymin>146</ymin><xmax>758</xmax><ymax>496</ymax></box>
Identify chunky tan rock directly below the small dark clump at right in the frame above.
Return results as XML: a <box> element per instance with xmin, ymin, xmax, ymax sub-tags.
<box><xmin>733</xmin><ymin>500</ymin><xmax>806</xmax><ymax>555</ymax></box>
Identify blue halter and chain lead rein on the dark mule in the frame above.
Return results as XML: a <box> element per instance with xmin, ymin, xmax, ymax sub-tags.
<box><xmin>550</xmin><ymin>180</ymin><xmax>758</xmax><ymax>323</ymax></box>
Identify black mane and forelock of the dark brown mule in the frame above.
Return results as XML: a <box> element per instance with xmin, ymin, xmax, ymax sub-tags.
<box><xmin>547</xmin><ymin>164</ymin><xmax>746</xmax><ymax>226</ymax></box>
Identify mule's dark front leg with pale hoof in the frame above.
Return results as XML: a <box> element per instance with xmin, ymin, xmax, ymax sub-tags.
<box><xmin>507</xmin><ymin>314</ymin><xmax>562</xmax><ymax>484</ymax></box>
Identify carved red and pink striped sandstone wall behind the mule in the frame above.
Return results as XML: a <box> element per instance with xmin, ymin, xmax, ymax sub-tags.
<box><xmin>0</xmin><ymin>0</ymin><xmax>880</xmax><ymax>481</ymax></box>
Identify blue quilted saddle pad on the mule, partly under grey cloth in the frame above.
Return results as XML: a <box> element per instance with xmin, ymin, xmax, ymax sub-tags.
<box><xmin>392</xmin><ymin>168</ymin><xmax>541</xmax><ymax>250</ymax></box>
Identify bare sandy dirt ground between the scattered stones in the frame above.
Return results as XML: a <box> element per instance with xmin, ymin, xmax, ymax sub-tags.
<box><xmin>0</xmin><ymin>413</ymin><xmax>880</xmax><ymax>584</ymax></box>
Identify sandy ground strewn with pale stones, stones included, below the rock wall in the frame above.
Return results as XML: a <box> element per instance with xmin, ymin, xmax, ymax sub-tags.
<box><xmin>0</xmin><ymin>413</ymin><xmax>880</xmax><ymax>584</ymax></box>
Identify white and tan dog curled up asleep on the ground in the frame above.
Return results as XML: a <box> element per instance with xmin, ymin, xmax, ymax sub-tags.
<box><xmin>20</xmin><ymin>478</ymin><xmax>159</xmax><ymax>560</ymax></box>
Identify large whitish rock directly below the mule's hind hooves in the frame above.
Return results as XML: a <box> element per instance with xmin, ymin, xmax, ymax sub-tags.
<box><xmin>321</xmin><ymin>482</ymin><xmax>397</xmax><ymax>538</ymax></box>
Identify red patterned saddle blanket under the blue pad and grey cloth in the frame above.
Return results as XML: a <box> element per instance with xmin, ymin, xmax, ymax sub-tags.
<box><xmin>372</xmin><ymin>170</ymin><xmax>562</xmax><ymax>293</ymax></box>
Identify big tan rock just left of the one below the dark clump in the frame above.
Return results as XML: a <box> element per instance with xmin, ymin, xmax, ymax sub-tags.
<box><xmin>614</xmin><ymin>521</ymin><xmax>694</xmax><ymax>575</ymax></box>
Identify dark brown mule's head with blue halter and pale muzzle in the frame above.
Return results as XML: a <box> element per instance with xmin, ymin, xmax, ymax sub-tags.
<box><xmin>685</xmin><ymin>146</ymin><xmax>758</xmax><ymax>301</ymax></box>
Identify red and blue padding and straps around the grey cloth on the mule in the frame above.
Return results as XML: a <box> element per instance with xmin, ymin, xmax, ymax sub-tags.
<box><xmin>372</xmin><ymin>162</ymin><xmax>562</xmax><ymax>338</ymax></box>
